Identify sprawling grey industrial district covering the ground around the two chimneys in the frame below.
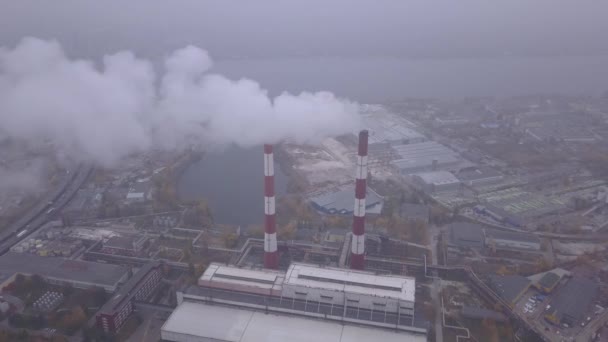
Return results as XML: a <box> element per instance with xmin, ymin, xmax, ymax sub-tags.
<box><xmin>0</xmin><ymin>92</ymin><xmax>608</xmax><ymax>341</ymax></box>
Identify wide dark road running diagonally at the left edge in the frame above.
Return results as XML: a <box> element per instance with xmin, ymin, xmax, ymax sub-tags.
<box><xmin>0</xmin><ymin>166</ymin><xmax>93</xmax><ymax>255</ymax></box>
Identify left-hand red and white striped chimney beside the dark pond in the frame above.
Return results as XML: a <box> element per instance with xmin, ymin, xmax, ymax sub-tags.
<box><xmin>264</xmin><ymin>144</ymin><xmax>279</xmax><ymax>269</ymax></box>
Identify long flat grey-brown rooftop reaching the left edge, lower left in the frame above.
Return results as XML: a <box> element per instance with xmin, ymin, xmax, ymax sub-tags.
<box><xmin>0</xmin><ymin>252</ymin><xmax>129</xmax><ymax>287</ymax></box>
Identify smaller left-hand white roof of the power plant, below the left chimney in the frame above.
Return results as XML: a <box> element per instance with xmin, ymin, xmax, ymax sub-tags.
<box><xmin>199</xmin><ymin>263</ymin><xmax>285</xmax><ymax>289</ymax></box>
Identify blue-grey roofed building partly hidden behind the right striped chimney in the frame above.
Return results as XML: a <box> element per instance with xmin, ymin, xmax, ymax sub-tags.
<box><xmin>310</xmin><ymin>183</ymin><xmax>383</xmax><ymax>215</ymax></box>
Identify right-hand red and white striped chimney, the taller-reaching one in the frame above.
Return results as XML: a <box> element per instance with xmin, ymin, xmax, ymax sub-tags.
<box><xmin>350</xmin><ymin>130</ymin><xmax>368</xmax><ymax>270</ymax></box>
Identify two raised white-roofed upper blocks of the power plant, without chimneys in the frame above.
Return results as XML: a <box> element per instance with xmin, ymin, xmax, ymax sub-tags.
<box><xmin>192</xmin><ymin>263</ymin><xmax>415</xmax><ymax>315</ymax></box>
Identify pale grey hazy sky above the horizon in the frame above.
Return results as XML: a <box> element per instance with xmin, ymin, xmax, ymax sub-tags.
<box><xmin>0</xmin><ymin>0</ymin><xmax>608</xmax><ymax>58</ymax></box>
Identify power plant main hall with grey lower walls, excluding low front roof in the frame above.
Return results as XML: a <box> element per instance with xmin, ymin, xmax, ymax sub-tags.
<box><xmin>177</xmin><ymin>263</ymin><xmax>427</xmax><ymax>341</ymax></box>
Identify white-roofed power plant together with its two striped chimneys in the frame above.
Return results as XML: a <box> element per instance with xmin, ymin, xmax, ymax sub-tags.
<box><xmin>161</xmin><ymin>131</ymin><xmax>426</xmax><ymax>342</ymax></box>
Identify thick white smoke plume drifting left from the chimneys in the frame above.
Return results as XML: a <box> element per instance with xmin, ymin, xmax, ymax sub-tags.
<box><xmin>0</xmin><ymin>38</ymin><xmax>359</xmax><ymax>166</ymax></box>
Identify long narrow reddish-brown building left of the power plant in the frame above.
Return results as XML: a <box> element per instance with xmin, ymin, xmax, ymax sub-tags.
<box><xmin>95</xmin><ymin>261</ymin><xmax>162</xmax><ymax>334</ymax></box>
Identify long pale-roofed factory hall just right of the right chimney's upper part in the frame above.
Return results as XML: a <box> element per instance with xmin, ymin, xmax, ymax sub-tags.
<box><xmin>391</xmin><ymin>141</ymin><xmax>463</xmax><ymax>175</ymax></box>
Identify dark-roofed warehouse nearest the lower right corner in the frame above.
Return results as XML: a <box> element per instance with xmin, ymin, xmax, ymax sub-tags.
<box><xmin>545</xmin><ymin>278</ymin><xmax>599</xmax><ymax>327</ymax></box>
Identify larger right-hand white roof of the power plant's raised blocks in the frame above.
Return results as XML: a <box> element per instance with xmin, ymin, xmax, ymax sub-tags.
<box><xmin>284</xmin><ymin>263</ymin><xmax>416</xmax><ymax>302</ymax></box>
